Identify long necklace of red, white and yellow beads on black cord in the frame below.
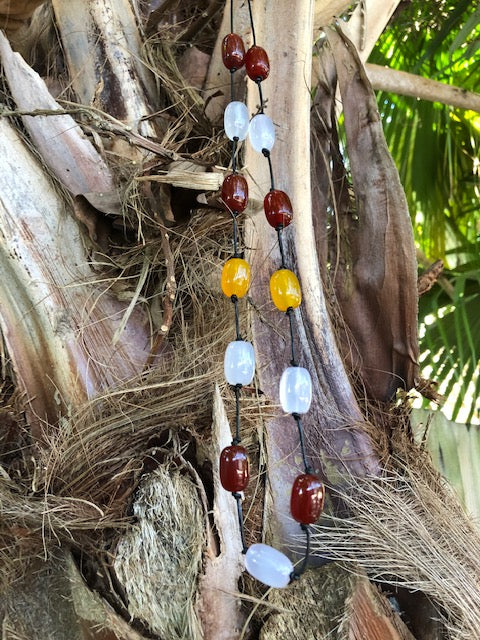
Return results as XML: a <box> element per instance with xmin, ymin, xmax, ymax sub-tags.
<box><xmin>220</xmin><ymin>0</ymin><xmax>325</xmax><ymax>588</ymax></box>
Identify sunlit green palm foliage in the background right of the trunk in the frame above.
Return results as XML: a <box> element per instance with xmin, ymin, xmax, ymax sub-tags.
<box><xmin>370</xmin><ymin>0</ymin><xmax>480</xmax><ymax>421</ymax></box>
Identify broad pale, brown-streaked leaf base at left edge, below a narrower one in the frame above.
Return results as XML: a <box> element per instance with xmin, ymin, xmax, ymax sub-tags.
<box><xmin>0</xmin><ymin>112</ymin><xmax>157</xmax><ymax>439</ymax></box>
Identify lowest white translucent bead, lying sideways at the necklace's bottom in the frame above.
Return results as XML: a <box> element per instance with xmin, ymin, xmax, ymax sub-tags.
<box><xmin>245</xmin><ymin>544</ymin><xmax>293</xmax><ymax>589</ymax></box>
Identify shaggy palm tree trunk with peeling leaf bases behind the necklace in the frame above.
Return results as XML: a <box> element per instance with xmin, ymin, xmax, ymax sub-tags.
<box><xmin>0</xmin><ymin>0</ymin><xmax>475</xmax><ymax>640</ymax></box>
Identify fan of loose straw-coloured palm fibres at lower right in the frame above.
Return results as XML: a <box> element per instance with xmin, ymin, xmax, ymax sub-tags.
<box><xmin>313</xmin><ymin>424</ymin><xmax>480</xmax><ymax>640</ymax></box>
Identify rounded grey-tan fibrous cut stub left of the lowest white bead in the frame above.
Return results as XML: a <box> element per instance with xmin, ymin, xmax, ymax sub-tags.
<box><xmin>113</xmin><ymin>464</ymin><xmax>206</xmax><ymax>640</ymax></box>
